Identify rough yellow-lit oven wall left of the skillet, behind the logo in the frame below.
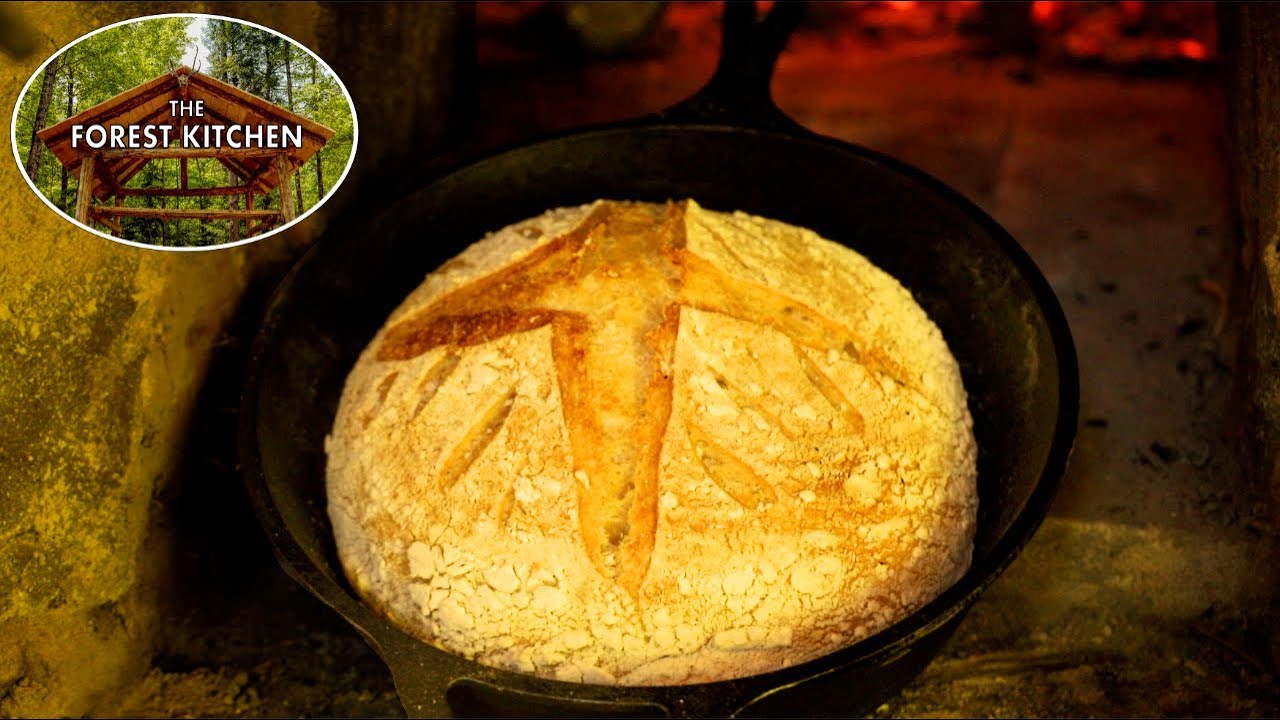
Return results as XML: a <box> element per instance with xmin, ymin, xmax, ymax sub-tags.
<box><xmin>0</xmin><ymin>3</ymin><xmax>460</xmax><ymax>717</ymax></box>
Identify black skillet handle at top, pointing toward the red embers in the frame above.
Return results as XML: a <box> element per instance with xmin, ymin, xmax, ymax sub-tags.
<box><xmin>658</xmin><ymin>0</ymin><xmax>809</xmax><ymax>135</ymax></box>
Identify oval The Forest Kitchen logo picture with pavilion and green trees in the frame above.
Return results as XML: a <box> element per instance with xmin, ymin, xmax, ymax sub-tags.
<box><xmin>14</xmin><ymin>15</ymin><xmax>356</xmax><ymax>247</ymax></box>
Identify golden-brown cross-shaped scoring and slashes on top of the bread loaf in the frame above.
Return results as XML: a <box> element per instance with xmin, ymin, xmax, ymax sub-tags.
<box><xmin>378</xmin><ymin>201</ymin><xmax>911</xmax><ymax>597</ymax></box>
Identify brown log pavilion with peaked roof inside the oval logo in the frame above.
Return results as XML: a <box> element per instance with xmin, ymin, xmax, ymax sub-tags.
<box><xmin>37</xmin><ymin>67</ymin><xmax>334</xmax><ymax>237</ymax></box>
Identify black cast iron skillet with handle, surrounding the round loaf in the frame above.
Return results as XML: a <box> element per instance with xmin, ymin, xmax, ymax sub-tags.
<box><xmin>241</xmin><ymin>3</ymin><xmax>1079</xmax><ymax>716</ymax></box>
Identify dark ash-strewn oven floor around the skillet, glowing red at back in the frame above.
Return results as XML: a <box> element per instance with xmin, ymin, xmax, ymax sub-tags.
<box><xmin>105</xmin><ymin>4</ymin><xmax>1280</xmax><ymax>717</ymax></box>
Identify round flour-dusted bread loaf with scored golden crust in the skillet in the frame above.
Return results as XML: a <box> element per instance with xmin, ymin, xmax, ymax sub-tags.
<box><xmin>326</xmin><ymin>200</ymin><xmax>977</xmax><ymax>684</ymax></box>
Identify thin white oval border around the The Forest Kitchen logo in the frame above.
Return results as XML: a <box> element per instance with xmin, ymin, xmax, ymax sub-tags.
<box><xmin>9</xmin><ymin>13</ymin><xmax>360</xmax><ymax>252</ymax></box>
